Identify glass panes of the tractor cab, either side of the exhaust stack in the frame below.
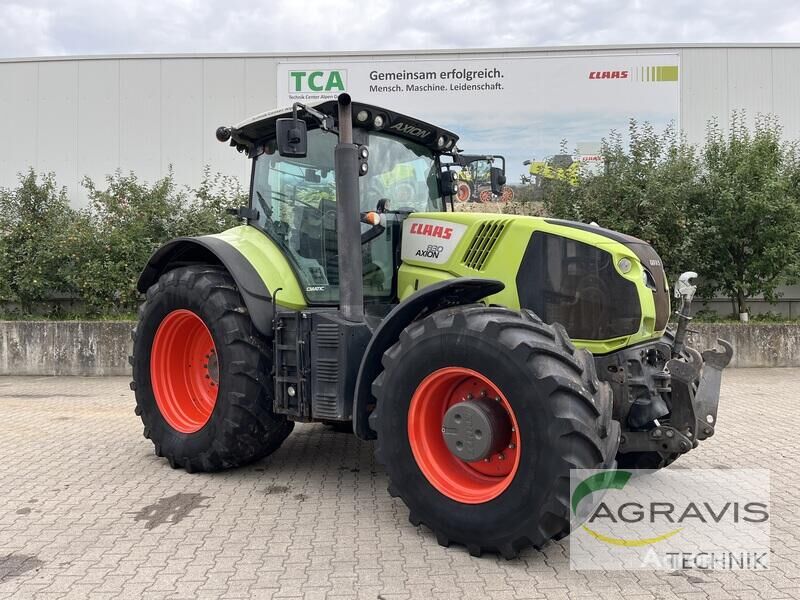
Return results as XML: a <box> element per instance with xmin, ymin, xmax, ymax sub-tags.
<box><xmin>251</xmin><ymin>129</ymin><xmax>443</xmax><ymax>303</ymax></box>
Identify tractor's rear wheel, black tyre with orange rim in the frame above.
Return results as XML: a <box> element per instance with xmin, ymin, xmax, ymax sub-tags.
<box><xmin>131</xmin><ymin>265</ymin><xmax>294</xmax><ymax>472</ymax></box>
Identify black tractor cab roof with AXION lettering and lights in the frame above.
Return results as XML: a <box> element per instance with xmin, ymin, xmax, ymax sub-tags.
<box><xmin>225</xmin><ymin>100</ymin><xmax>458</xmax><ymax>154</ymax></box>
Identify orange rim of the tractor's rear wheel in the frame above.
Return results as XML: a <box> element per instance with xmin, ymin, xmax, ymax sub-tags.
<box><xmin>150</xmin><ymin>309</ymin><xmax>219</xmax><ymax>433</ymax></box>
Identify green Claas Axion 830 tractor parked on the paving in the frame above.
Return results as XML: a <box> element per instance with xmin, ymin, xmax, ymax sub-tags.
<box><xmin>131</xmin><ymin>94</ymin><xmax>731</xmax><ymax>557</ymax></box>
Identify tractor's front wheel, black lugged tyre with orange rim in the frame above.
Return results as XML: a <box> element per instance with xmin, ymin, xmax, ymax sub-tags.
<box><xmin>372</xmin><ymin>306</ymin><xmax>619</xmax><ymax>558</ymax></box>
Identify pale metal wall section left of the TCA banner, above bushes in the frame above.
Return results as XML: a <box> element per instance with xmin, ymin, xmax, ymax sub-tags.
<box><xmin>0</xmin><ymin>58</ymin><xmax>276</xmax><ymax>204</ymax></box>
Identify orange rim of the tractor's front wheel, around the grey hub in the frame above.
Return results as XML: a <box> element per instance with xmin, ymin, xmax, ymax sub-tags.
<box><xmin>408</xmin><ymin>367</ymin><xmax>520</xmax><ymax>504</ymax></box>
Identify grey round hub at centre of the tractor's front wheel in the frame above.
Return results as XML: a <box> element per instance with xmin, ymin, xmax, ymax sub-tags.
<box><xmin>442</xmin><ymin>398</ymin><xmax>511</xmax><ymax>462</ymax></box>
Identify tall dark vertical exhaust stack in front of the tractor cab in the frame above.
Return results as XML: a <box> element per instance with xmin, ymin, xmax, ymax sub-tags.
<box><xmin>334</xmin><ymin>94</ymin><xmax>364</xmax><ymax>323</ymax></box>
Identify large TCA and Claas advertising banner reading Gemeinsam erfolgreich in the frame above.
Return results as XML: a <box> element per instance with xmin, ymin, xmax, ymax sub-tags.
<box><xmin>277</xmin><ymin>53</ymin><xmax>680</xmax><ymax>183</ymax></box>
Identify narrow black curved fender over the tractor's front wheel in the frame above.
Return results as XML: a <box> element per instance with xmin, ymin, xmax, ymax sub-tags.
<box><xmin>353</xmin><ymin>277</ymin><xmax>505</xmax><ymax>440</ymax></box>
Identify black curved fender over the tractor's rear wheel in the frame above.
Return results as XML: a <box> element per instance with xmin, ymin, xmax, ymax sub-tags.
<box><xmin>136</xmin><ymin>235</ymin><xmax>273</xmax><ymax>337</ymax></box>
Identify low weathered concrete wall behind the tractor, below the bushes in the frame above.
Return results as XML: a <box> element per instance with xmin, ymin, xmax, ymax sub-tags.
<box><xmin>0</xmin><ymin>321</ymin><xmax>800</xmax><ymax>375</ymax></box>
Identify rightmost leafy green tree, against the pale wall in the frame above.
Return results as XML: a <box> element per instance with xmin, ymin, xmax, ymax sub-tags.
<box><xmin>695</xmin><ymin>113</ymin><xmax>800</xmax><ymax>315</ymax></box>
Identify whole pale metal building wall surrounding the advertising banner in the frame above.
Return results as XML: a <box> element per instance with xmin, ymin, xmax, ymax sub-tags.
<box><xmin>0</xmin><ymin>46</ymin><xmax>800</xmax><ymax>204</ymax></box>
